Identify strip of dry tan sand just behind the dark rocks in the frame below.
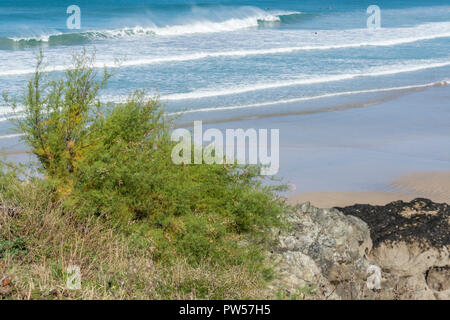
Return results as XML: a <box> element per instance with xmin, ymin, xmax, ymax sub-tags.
<box><xmin>289</xmin><ymin>171</ymin><xmax>450</xmax><ymax>208</ymax></box>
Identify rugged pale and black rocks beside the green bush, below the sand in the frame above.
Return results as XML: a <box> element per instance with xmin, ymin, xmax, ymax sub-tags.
<box><xmin>271</xmin><ymin>199</ymin><xmax>450</xmax><ymax>299</ymax></box>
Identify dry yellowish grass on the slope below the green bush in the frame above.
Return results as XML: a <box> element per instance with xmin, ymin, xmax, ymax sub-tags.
<box><xmin>0</xmin><ymin>179</ymin><xmax>263</xmax><ymax>299</ymax></box>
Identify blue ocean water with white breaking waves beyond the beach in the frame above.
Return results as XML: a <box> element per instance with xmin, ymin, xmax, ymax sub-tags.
<box><xmin>0</xmin><ymin>0</ymin><xmax>450</xmax><ymax>138</ymax></box>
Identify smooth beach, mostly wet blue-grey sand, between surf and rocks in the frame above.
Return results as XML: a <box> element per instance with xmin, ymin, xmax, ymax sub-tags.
<box><xmin>0</xmin><ymin>86</ymin><xmax>450</xmax><ymax>207</ymax></box>
